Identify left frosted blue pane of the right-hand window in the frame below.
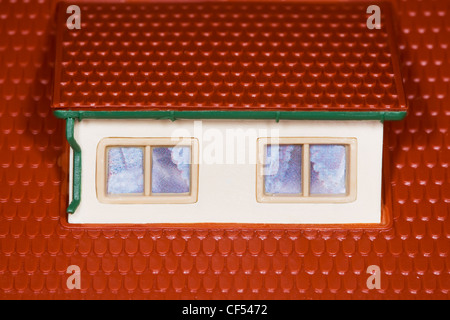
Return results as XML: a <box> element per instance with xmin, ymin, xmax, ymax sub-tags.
<box><xmin>264</xmin><ymin>144</ymin><xmax>302</xmax><ymax>194</ymax></box>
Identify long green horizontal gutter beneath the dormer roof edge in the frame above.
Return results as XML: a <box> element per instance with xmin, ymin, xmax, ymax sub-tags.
<box><xmin>54</xmin><ymin>110</ymin><xmax>406</xmax><ymax>122</ymax></box>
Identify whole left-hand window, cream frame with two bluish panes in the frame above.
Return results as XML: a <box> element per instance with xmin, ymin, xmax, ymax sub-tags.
<box><xmin>96</xmin><ymin>138</ymin><xmax>198</xmax><ymax>203</ymax></box>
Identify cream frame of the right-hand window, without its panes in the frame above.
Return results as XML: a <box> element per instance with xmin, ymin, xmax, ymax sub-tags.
<box><xmin>256</xmin><ymin>137</ymin><xmax>357</xmax><ymax>203</ymax></box>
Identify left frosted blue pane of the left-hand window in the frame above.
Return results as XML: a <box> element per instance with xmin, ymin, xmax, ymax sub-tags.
<box><xmin>107</xmin><ymin>147</ymin><xmax>144</xmax><ymax>194</ymax></box>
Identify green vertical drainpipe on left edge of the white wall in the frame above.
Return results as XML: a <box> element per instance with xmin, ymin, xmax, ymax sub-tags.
<box><xmin>66</xmin><ymin>118</ymin><xmax>81</xmax><ymax>213</ymax></box>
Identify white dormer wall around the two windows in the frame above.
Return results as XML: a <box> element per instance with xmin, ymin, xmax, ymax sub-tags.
<box><xmin>69</xmin><ymin>119</ymin><xmax>383</xmax><ymax>224</ymax></box>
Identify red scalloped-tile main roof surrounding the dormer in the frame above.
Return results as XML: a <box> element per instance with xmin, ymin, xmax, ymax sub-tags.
<box><xmin>0</xmin><ymin>0</ymin><xmax>450</xmax><ymax>299</ymax></box>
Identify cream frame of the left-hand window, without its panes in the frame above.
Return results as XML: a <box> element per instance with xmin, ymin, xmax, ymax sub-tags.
<box><xmin>95</xmin><ymin>137</ymin><xmax>199</xmax><ymax>204</ymax></box>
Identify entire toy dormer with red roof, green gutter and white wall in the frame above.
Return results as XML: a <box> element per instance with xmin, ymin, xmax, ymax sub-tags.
<box><xmin>53</xmin><ymin>3</ymin><xmax>406</xmax><ymax>226</ymax></box>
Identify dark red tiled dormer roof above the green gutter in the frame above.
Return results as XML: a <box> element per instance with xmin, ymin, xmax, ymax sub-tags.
<box><xmin>53</xmin><ymin>2</ymin><xmax>406</xmax><ymax>111</ymax></box>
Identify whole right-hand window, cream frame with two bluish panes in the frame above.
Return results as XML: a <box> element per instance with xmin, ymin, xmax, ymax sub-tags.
<box><xmin>256</xmin><ymin>138</ymin><xmax>356</xmax><ymax>203</ymax></box>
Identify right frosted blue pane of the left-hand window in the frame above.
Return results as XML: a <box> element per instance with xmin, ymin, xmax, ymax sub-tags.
<box><xmin>152</xmin><ymin>147</ymin><xmax>191</xmax><ymax>193</ymax></box>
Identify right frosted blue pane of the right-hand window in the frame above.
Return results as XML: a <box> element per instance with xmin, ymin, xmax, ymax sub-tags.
<box><xmin>309</xmin><ymin>144</ymin><xmax>347</xmax><ymax>194</ymax></box>
